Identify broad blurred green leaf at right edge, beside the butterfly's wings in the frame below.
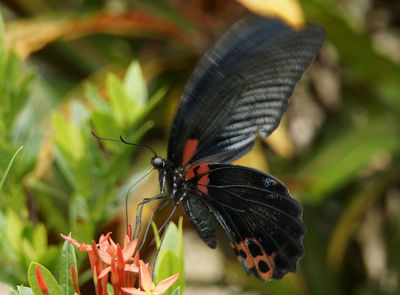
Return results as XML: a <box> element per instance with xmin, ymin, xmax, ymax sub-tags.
<box><xmin>299</xmin><ymin>120</ymin><xmax>400</xmax><ymax>202</ymax></box>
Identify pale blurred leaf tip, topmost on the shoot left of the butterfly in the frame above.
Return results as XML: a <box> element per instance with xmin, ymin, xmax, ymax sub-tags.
<box><xmin>124</xmin><ymin>61</ymin><xmax>147</xmax><ymax>108</ymax></box>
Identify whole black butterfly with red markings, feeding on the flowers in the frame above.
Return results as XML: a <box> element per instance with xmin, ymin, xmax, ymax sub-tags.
<box><xmin>145</xmin><ymin>15</ymin><xmax>325</xmax><ymax>280</ymax></box>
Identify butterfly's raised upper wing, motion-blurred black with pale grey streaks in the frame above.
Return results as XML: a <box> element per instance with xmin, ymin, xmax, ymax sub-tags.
<box><xmin>168</xmin><ymin>15</ymin><xmax>325</xmax><ymax>165</ymax></box>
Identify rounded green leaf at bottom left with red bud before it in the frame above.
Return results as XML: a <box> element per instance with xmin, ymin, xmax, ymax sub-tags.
<box><xmin>28</xmin><ymin>262</ymin><xmax>63</xmax><ymax>295</ymax></box>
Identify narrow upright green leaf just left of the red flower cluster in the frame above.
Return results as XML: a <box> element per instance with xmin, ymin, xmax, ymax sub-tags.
<box><xmin>59</xmin><ymin>241</ymin><xmax>78</xmax><ymax>295</ymax></box>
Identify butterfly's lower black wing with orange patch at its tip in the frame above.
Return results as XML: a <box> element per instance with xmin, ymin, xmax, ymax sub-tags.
<box><xmin>186</xmin><ymin>164</ymin><xmax>305</xmax><ymax>280</ymax></box>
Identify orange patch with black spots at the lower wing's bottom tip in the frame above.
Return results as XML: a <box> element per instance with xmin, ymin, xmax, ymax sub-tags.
<box><xmin>231</xmin><ymin>239</ymin><xmax>275</xmax><ymax>281</ymax></box>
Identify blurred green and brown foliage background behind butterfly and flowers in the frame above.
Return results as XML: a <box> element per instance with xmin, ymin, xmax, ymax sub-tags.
<box><xmin>0</xmin><ymin>0</ymin><xmax>400</xmax><ymax>295</ymax></box>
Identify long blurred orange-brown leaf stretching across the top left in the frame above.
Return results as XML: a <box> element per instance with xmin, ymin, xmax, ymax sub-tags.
<box><xmin>5</xmin><ymin>11</ymin><xmax>190</xmax><ymax>59</ymax></box>
